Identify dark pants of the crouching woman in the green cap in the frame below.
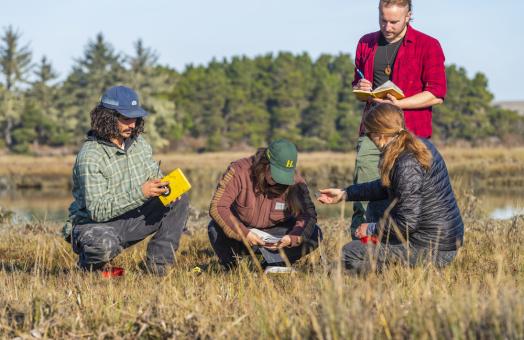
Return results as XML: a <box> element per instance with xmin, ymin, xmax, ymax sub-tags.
<box><xmin>207</xmin><ymin>220</ymin><xmax>322</xmax><ymax>268</ymax></box>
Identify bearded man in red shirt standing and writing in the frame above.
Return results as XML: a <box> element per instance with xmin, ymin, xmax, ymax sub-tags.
<box><xmin>351</xmin><ymin>0</ymin><xmax>446</xmax><ymax>235</ymax></box>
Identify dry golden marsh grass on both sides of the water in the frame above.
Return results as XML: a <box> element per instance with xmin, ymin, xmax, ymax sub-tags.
<box><xmin>0</xmin><ymin>149</ymin><xmax>524</xmax><ymax>339</ymax></box>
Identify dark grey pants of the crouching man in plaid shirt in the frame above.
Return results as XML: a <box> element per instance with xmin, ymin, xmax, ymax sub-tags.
<box><xmin>72</xmin><ymin>195</ymin><xmax>189</xmax><ymax>269</ymax></box>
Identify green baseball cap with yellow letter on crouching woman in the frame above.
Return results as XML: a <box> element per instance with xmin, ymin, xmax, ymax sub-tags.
<box><xmin>266</xmin><ymin>139</ymin><xmax>297</xmax><ymax>185</ymax></box>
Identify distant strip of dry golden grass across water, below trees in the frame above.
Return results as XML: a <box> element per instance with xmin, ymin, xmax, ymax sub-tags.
<box><xmin>0</xmin><ymin>147</ymin><xmax>524</xmax><ymax>191</ymax></box>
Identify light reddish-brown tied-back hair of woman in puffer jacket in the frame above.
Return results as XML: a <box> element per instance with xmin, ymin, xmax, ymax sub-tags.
<box><xmin>364</xmin><ymin>103</ymin><xmax>432</xmax><ymax>187</ymax></box>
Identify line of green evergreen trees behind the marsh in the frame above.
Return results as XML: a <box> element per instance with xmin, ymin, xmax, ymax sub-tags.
<box><xmin>0</xmin><ymin>26</ymin><xmax>524</xmax><ymax>153</ymax></box>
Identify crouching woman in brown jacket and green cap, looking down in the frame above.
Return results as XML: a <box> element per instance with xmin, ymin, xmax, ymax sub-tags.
<box><xmin>208</xmin><ymin>139</ymin><xmax>322</xmax><ymax>271</ymax></box>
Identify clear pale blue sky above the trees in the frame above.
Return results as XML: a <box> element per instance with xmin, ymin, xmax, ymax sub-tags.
<box><xmin>0</xmin><ymin>0</ymin><xmax>524</xmax><ymax>100</ymax></box>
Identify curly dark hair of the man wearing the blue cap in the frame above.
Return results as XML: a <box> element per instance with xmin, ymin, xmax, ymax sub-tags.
<box><xmin>91</xmin><ymin>105</ymin><xmax>144</xmax><ymax>141</ymax></box>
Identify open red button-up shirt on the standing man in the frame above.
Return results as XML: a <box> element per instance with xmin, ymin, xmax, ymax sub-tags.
<box><xmin>353</xmin><ymin>25</ymin><xmax>446</xmax><ymax>138</ymax></box>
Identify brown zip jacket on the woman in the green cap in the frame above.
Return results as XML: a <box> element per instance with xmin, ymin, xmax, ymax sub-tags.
<box><xmin>209</xmin><ymin>156</ymin><xmax>317</xmax><ymax>246</ymax></box>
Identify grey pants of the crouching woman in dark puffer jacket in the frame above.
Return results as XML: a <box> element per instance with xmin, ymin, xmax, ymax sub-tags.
<box><xmin>342</xmin><ymin>241</ymin><xmax>457</xmax><ymax>274</ymax></box>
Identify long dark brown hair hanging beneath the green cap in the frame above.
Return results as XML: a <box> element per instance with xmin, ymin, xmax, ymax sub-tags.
<box><xmin>251</xmin><ymin>148</ymin><xmax>303</xmax><ymax>217</ymax></box>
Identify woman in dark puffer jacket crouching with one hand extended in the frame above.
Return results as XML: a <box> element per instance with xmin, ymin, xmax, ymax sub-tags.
<box><xmin>318</xmin><ymin>103</ymin><xmax>464</xmax><ymax>273</ymax></box>
